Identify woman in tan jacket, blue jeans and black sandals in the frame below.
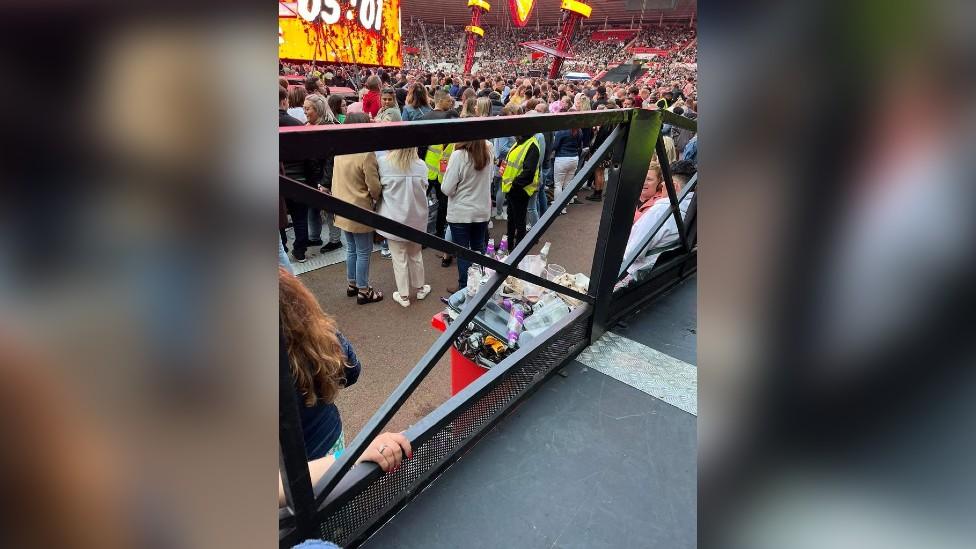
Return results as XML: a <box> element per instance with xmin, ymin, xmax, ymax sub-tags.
<box><xmin>332</xmin><ymin>113</ymin><xmax>383</xmax><ymax>305</ymax></box>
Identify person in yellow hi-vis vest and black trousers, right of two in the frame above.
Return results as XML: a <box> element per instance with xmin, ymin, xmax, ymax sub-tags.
<box><xmin>502</xmin><ymin>135</ymin><xmax>542</xmax><ymax>249</ymax></box>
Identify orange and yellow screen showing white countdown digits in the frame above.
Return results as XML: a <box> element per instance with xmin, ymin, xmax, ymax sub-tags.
<box><xmin>278</xmin><ymin>0</ymin><xmax>403</xmax><ymax>67</ymax></box>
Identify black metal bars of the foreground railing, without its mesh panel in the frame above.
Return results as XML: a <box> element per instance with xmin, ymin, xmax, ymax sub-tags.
<box><xmin>279</xmin><ymin>109</ymin><xmax>696</xmax><ymax>547</ymax></box>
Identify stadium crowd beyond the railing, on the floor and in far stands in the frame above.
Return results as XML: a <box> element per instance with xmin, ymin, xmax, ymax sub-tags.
<box><xmin>279</xmin><ymin>24</ymin><xmax>698</xmax><ymax>296</ymax></box>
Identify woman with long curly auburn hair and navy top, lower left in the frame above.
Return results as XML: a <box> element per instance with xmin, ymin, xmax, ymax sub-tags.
<box><xmin>278</xmin><ymin>267</ymin><xmax>362</xmax><ymax>460</ymax></box>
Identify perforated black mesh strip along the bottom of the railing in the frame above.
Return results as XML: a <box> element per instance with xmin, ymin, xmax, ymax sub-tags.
<box><xmin>321</xmin><ymin>315</ymin><xmax>589</xmax><ymax>546</ymax></box>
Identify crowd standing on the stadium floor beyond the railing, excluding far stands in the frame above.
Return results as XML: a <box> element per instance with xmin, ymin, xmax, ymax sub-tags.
<box><xmin>279</xmin><ymin>63</ymin><xmax>698</xmax><ymax>294</ymax></box>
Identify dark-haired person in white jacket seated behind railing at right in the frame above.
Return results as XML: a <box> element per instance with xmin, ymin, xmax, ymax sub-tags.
<box><xmin>624</xmin><ymin>160</ymin><xmax>696</xmax><ymax>283</ymax></box>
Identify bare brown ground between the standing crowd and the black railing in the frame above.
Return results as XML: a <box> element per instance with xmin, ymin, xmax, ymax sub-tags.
<box><xmin>300</xmin><ymin>190</ymin><xmax>603</xmax><ymax>443</ymax></box>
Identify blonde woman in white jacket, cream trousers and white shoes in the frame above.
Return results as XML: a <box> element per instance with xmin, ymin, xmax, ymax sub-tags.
<box><xmin>376</xmin><ymin>147</ymin><xmax>430</xmax><ymax>307</ymax></box>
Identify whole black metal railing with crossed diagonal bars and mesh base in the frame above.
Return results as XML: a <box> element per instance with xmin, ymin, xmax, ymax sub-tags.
<box><xmin>279</xmin><ymin>105</ymin><xmax>696</xmax><ymax>547</ymax></box>
